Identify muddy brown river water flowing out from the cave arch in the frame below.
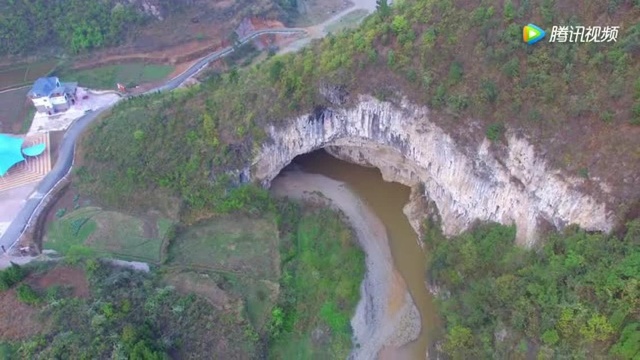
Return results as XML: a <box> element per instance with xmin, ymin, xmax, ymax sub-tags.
<box><xmin>294</xmin><ymin>150</ymin><xmax>437</xmax><ymax>360</ymax></box>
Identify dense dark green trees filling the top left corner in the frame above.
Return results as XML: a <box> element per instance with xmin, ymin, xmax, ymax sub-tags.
<box><xmin>0</xmin><ymin>0</ymin><xmax>144</xmax><ymax>55</ymax></box>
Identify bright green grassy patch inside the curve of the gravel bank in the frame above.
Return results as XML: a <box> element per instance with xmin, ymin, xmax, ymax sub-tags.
<box><xmin>270</xmin><ymin>209</ymin><xmax>365</xmax><ymax>359</ymax></box>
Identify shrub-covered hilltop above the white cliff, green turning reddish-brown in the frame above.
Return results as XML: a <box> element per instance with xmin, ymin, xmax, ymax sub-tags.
<box><xmin>82</xmin><ymin>0</ymin><xmax>640</xmax><ymax>214</ymax></box>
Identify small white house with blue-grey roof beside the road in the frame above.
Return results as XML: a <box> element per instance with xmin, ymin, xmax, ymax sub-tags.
<box><xmin>27</xmin><ymin>77</ymin><xmax>78</xmax><ymax>114</ymax></box>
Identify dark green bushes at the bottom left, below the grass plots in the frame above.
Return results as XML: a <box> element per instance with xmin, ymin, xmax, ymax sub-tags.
<box><xmin>13</xmin><ymin>260</ymin><xmax>255</xmax><ymax>360</ymax></box>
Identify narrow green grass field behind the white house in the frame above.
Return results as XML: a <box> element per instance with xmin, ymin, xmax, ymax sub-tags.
<box><xmin>60</xmin><ymin>63</ymin><xmax>175</xmax><ymax>89</ymax></box>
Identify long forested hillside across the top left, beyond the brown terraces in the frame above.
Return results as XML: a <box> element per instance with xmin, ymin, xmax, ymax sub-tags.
<box><xmin>0</xmin><ymin>0</ymin><xmax>296</xmax><ymax>56</ymax></box>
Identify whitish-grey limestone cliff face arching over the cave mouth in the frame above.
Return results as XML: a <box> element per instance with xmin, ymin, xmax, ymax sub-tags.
<box><xmin>251</xmin><ymin>96</ymin><xmax>613</xmax><ymax>245</ymax></box>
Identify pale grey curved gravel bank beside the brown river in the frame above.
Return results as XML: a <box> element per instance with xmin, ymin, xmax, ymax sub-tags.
<box><xmin>271</xmin><ymin>170</ymin><xmax>420</xmax><ymax>360</ymax></box>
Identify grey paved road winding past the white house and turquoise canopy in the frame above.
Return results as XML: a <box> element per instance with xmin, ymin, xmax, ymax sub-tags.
<box><xmin>0</xmin><ymin>28</ymin><xmax>306</xmax><ymax>251</ymax></box>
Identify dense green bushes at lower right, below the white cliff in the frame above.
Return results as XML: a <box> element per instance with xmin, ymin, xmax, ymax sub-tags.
<box><xmin>427</xmin><ymin>220</ymin><xmax>640</xmax><ymax>359</ymax></box>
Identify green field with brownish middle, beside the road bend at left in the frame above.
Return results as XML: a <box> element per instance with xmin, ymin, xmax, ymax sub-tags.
<box><xmin>44</xmin><ymin>207</ymin><xmax>172</xmax><ymax>263</ymax></box>
